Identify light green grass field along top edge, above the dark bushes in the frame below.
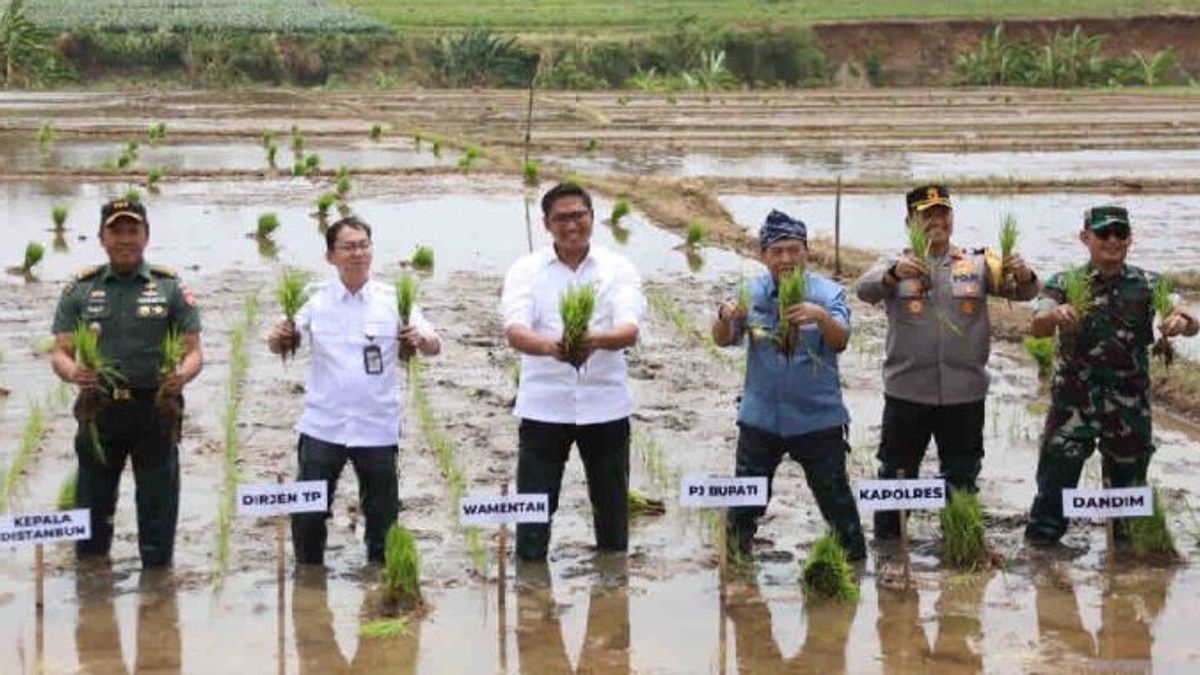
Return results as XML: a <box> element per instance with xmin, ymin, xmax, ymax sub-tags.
<box><xmin>345</xmin><ymin>0</ymin><xmax>1180</xmax><ymax>36</ymax></box>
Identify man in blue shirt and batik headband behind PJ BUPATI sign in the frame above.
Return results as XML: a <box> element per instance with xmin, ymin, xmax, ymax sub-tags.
<box><xmin>713</xmin><ymin>210</ymin><xmax>866</xmax><ymax>560</ymax></box>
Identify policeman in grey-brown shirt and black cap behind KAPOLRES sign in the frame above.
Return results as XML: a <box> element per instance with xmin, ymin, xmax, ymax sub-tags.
<box><xmin>858</xmin><ymin>185</ymin><xmax>1038</xmax><ymax>539</ymax></box>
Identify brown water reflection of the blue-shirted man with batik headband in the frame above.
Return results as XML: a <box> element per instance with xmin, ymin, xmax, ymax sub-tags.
<box><xmin>728</xmin><ymin>571</ymin><xmax>858</xmax><ymax>675</ymax></box>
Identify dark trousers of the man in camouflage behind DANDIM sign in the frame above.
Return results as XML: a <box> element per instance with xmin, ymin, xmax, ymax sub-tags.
<box><xmin>1025</xmin><ymin>441</ymin><xmax>1152</xmax><ymax>542</ymax></box>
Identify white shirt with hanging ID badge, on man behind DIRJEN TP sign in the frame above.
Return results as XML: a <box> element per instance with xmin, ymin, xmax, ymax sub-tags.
<box><xmin>296</xmin><ymin>277</ymin><xmax>433</xmax><ymax>447</ymax></box>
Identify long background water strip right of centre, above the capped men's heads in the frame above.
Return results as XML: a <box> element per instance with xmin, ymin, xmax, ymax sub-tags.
<box><xmin>545</xmin><ymin>148</ymin><xmax>1200</xmax><ymax>183</ymax></box>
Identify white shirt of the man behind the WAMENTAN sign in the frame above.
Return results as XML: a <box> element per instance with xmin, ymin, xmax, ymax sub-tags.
<box><xmin>500</xmin><ymin>244</ymin><xmax>646</xmax><ymax>424</ymax></box>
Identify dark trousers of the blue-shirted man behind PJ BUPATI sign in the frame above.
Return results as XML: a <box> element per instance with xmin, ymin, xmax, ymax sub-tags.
<box><xmin>726</xmin><ymin>424</ymin><xmax>866</xmax><ymax>560</ymax></box>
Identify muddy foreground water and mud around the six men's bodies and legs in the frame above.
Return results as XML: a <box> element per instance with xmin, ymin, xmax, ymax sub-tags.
<box><xmin>0</xmin><ymin>268</ymin><xmax>1200</xmax><ymax>673</ymax></box>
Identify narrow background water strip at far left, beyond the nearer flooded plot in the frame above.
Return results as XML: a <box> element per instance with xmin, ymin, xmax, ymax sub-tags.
<box><xmin>0</xmin><ymin>136</ymin><xmax>458</xmax><ymax>175</ymax></box>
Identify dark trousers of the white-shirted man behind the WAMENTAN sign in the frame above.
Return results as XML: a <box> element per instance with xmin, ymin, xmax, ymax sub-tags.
<box><xmin>517</xmin><ymin>418</ymin><xmax>629</xmax><ymax>560</ymax></box>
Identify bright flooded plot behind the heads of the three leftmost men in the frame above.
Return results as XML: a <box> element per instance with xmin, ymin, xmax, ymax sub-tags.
<box><xmin>0</xmin><ymin>179</ymin><xmax>742</xmax><ymax>285</ymax></box>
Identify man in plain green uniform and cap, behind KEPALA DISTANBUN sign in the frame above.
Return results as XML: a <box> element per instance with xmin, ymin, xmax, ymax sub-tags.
<box><xmin>52</xmin><ymin>199</ymin><xmax>203</xmax><ymax>567</ymax></box>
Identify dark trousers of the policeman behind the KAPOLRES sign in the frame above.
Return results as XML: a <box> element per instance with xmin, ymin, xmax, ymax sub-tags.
<box><xmin>875</xmin><ymin>396</ymin><xmax>984</xmax><ymax>539</ymax></box>
